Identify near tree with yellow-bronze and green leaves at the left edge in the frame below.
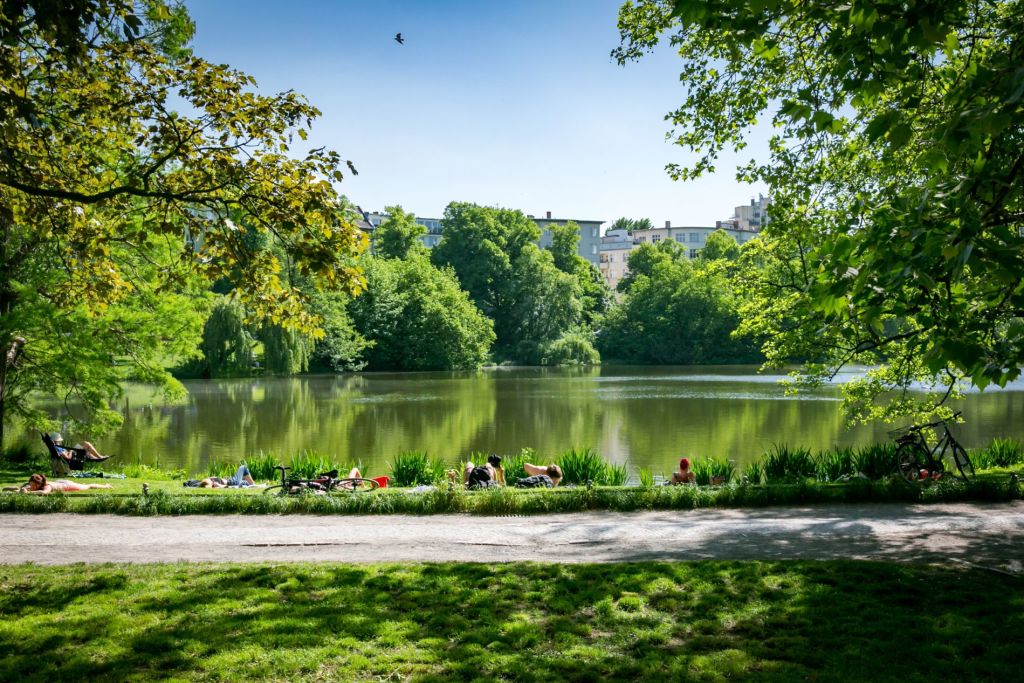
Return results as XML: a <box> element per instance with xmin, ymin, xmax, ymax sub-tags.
<box><xmin>0</xmin><ymin>0</ymin><xmax>366</xmax><ymax>445</ymax></box>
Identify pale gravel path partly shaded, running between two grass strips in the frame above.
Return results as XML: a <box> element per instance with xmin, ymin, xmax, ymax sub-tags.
<box><xmin>0</xmin><ymin>502</ymin><xmax>1024</xmax><ymax>574</ymax></box>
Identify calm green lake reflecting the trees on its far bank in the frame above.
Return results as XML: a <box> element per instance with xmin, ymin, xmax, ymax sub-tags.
<box><xmin>22</xmin><ymin>367</ymin><xmax>1024</xmax><ymax>475</ymax></box>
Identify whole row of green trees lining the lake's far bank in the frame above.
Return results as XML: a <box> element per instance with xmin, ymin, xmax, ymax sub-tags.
<box><xmin>192</xmin><ymin>202</ymin><xmax>762</xmax><ymax>377</ymax></box>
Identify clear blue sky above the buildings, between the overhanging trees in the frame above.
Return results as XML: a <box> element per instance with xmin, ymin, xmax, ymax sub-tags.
<box><xmin>186</xmin><ymin>0</ymin><xmax>765</xmax><ymax>225</ymax></box>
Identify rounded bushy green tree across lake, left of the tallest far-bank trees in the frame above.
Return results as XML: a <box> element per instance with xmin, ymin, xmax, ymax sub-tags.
<box><xmin>349</xmin><ymin>252</ymin><xmax>495</xmax><ymax>370</ymax></box>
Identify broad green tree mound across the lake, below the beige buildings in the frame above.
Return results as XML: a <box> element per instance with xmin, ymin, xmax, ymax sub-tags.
<box><xmin>598</xmin><ymin>241</ymin><xmax>761</xmax><ymax>365</ymax></box>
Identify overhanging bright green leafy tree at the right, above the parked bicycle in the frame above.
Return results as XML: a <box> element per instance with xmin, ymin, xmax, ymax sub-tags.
<box><xmin>614</xmin><ymin>0</ymin><xmax>1024</xmax><ymax>419</ymax></box>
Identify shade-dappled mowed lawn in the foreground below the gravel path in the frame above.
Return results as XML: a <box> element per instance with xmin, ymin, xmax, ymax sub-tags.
<box><xmin>0</xmin><ymin>561</ymin><xmax>1024</xmax><ymax>681</ymax></box>
